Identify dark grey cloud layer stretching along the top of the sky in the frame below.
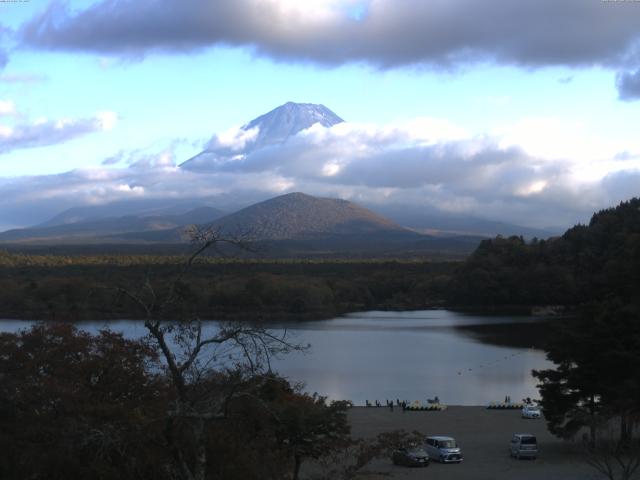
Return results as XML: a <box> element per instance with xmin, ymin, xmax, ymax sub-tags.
<box><xmin>18</xmin><ymin>0</ymin><xmax>640</xmax><ymax>100</ymax></box>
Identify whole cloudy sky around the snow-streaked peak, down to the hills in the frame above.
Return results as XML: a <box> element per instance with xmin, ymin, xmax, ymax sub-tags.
<box><xmin>0</xmin><ymin>0</ymin><xmax>640</xmax><ymax>230</ymax></box>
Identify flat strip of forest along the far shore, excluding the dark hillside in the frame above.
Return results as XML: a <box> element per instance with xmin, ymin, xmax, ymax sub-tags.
<box><xmin>0</xmin><ymin>252</ymin><xmax>456</xmax><ymax>320</ymax></box>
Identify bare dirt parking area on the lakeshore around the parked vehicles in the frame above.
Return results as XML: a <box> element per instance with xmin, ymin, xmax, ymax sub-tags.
<box><xmin>349</xmin><ymin>407</ymin><xmax>602</xmax><ymax>480</ymax></box>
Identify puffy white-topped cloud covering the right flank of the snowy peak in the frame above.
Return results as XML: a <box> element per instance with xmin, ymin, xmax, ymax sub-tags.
<box><xmin>185</xmin><ymin>119</ymin><xmax>568</xmax><ymax>205</ymax></box>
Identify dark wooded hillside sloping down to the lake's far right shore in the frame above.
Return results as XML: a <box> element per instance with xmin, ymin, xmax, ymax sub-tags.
<box><xmin>447</xmin><ymin>198</ymin><xmax>640</xmax><ymax>306</ymax></box>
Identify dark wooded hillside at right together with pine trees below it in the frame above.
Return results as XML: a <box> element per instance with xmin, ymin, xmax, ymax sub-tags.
<box><xmin>447</xmin><ymin>198</ymin><xmax>640</xmax><ymax>474</ymax></box>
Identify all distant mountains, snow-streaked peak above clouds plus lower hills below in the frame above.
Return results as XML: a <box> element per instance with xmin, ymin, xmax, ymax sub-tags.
<box><xmin>0</xmin><ymin>102</ymin><xmax>558</xmax><ymax>252</ymax></box>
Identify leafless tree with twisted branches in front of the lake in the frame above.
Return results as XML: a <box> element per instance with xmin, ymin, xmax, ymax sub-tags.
<box><xmin>112</xmin><ymin>227</ymin><xmax>302</xmax><ymax>480</ymax></box>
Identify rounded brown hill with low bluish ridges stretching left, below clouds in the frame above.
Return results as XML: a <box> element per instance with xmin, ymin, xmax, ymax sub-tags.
<box><xmin>0</xmin><ymin>193</ymin><xmax>480</xmax><ymax>255</ymax></box>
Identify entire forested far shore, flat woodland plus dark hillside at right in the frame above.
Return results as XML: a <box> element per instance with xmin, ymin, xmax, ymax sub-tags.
<box><xmin>0</xmin><ymin>198</ymin><xmax>640</xmax><ymax>320</ymax></box>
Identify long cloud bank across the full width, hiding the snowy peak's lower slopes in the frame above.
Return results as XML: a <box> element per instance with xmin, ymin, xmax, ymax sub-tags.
<box><xmin>0</xmin><ymin>119</ymin><xmax>640</xmax><ymax>233</ymax></box>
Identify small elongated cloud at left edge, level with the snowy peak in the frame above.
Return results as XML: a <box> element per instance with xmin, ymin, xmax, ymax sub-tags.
<box><xmin>0</xmin><ymin>112</ymin><xmax>117</xmax><ymax>155</ymax></box>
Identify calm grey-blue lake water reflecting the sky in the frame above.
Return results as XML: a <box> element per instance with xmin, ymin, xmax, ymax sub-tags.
<box><xmin>0</xmin><ymin>310</ymin><xmax>551</xmax><ymax>405</ymax></box>
